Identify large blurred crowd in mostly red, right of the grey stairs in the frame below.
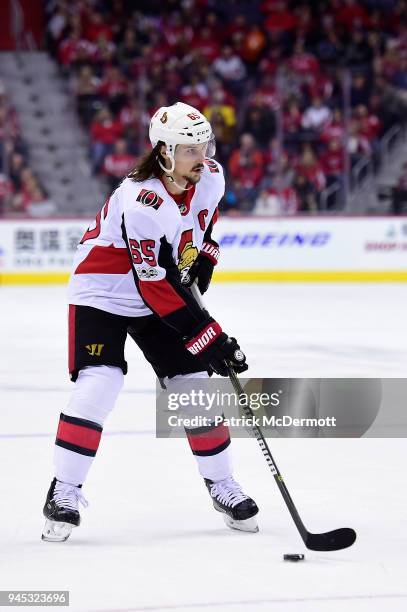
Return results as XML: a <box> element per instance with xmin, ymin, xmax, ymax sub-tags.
<box><xmin>36</xmin><ymin>0</ymin><xmax>407</xmax><ymax>214</ymax></box>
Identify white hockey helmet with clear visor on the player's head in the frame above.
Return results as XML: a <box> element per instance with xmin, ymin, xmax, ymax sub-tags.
<box><xmin>149</xmin><ymin>102</ymin><xmax>215</xmax><ymax>158</ymax></box>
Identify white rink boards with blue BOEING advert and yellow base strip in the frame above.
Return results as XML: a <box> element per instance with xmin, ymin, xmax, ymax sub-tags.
<box><xmin>0</xmin><ymin>216</ymin><xmax>407</xmax><ymax>284</ymax></box>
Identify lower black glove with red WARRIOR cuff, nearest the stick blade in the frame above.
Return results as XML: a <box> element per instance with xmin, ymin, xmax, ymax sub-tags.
<box><xmin>184</xmin><ymin>317</ymin><xmax>249</xmax><ymax>376</ymax></box>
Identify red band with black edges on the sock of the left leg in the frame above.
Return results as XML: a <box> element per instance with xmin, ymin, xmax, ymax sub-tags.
<box><xmin>55</xmin><ymin>412</ymin><xmax>103</xmax><ymax>457</ymax></box>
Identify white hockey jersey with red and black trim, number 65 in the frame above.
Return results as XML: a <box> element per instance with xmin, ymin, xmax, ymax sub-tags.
<box><xmin>68</xmin><ymin>159</ymin><xmax>225</xmax><ymax>328</ymax></box>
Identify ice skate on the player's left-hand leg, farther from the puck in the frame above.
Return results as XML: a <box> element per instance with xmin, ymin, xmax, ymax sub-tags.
<box><xmin>42</xmin><ymin>478</ymin><xmax>88</xmax><ymax>542</ymax></box>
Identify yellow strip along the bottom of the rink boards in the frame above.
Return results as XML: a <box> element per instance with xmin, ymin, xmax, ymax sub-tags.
<box><xmin>0</xmin><ymin>269</ymin><xmax>407</xmax><ymax>285</ymax></box>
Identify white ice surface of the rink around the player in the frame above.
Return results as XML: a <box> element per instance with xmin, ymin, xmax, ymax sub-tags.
<box><xmin>0</xmin><ymin>284</ymin><xmax>407</xmax><ymax>612</ymax></box>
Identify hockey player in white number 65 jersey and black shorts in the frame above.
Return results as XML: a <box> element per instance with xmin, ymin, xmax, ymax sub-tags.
<box><xmin>42</xmin><ymin>102</ymin><xmax>258</xmax><ymax>541</ymax></box>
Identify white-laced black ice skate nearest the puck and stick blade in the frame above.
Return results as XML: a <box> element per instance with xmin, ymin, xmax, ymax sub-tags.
<box><xmin>205</xmin><ymin>476</ymin><xmax>259</xmax><ymax>533</ymax></box>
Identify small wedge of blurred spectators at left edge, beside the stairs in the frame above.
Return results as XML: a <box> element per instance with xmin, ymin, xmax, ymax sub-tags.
<box><xmin>0</xmin><ymin>81</ymin><xmax>56</xmax><ymax>217</ymax></box>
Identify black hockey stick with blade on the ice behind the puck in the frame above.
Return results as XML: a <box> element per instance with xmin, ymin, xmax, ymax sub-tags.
<box><xmin>191</xmin><ymin>284</ymin><xmax>356</xmax><ymax>551</ymax></box>
